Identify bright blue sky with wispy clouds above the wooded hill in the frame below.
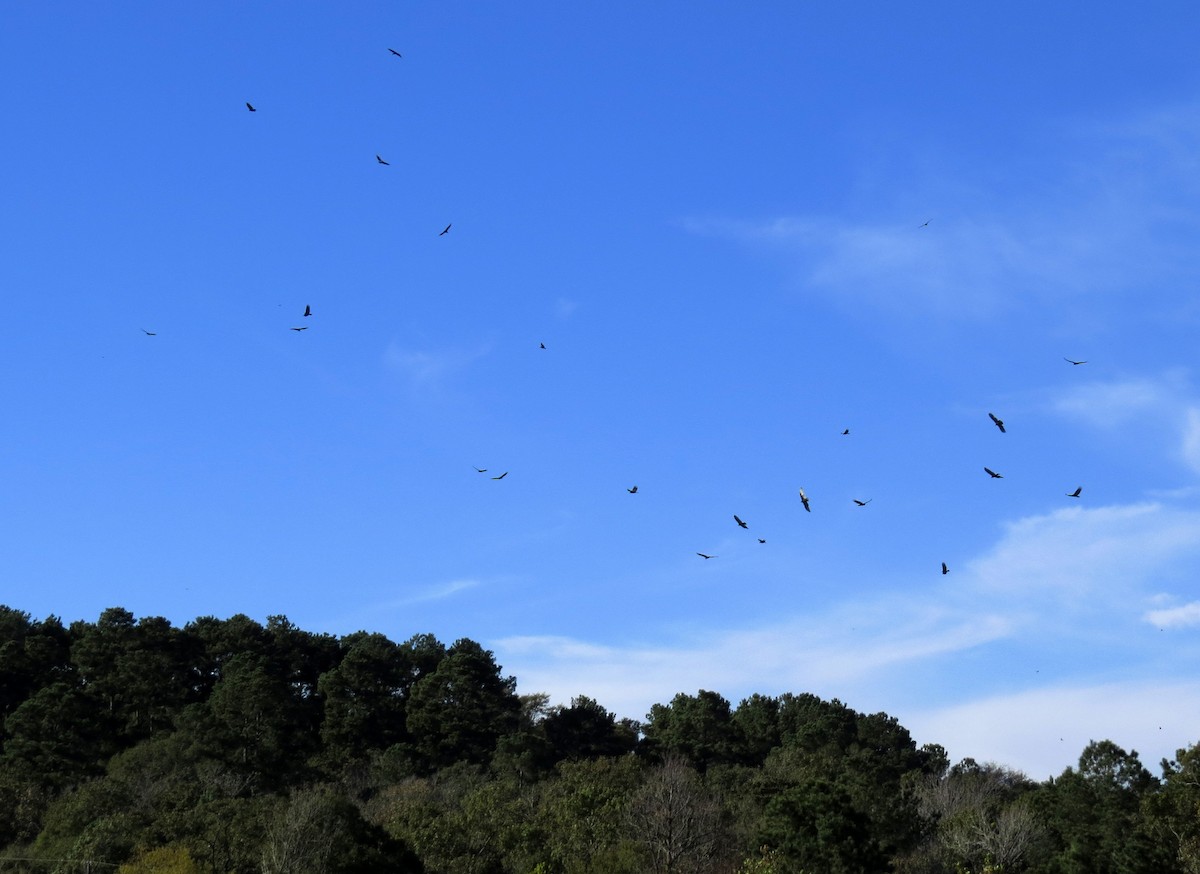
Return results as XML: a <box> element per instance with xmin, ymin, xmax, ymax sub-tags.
<box><xmin>0</xmin><ymin>1</ymin><xmax>1200</xmax><ymax>778</ymax></box>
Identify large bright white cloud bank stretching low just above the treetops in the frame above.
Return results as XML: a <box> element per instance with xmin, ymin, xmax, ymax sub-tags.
<box><xmin>492</xmin><ymin>494</ymin><xmax>1200</xmax><ymax>778</ymax></box>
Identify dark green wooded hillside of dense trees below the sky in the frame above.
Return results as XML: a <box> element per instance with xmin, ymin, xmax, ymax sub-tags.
<box><xmin>0</xmin><ymin>606</ymin><xmax>1200</xmax><ymax>874</ymax></box>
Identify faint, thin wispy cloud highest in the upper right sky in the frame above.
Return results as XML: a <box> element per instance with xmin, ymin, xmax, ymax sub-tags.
<box><xmin>682</xmin><ymin>107</ymin><xmax>1200</xmax><ymax>319</ymax></box>
